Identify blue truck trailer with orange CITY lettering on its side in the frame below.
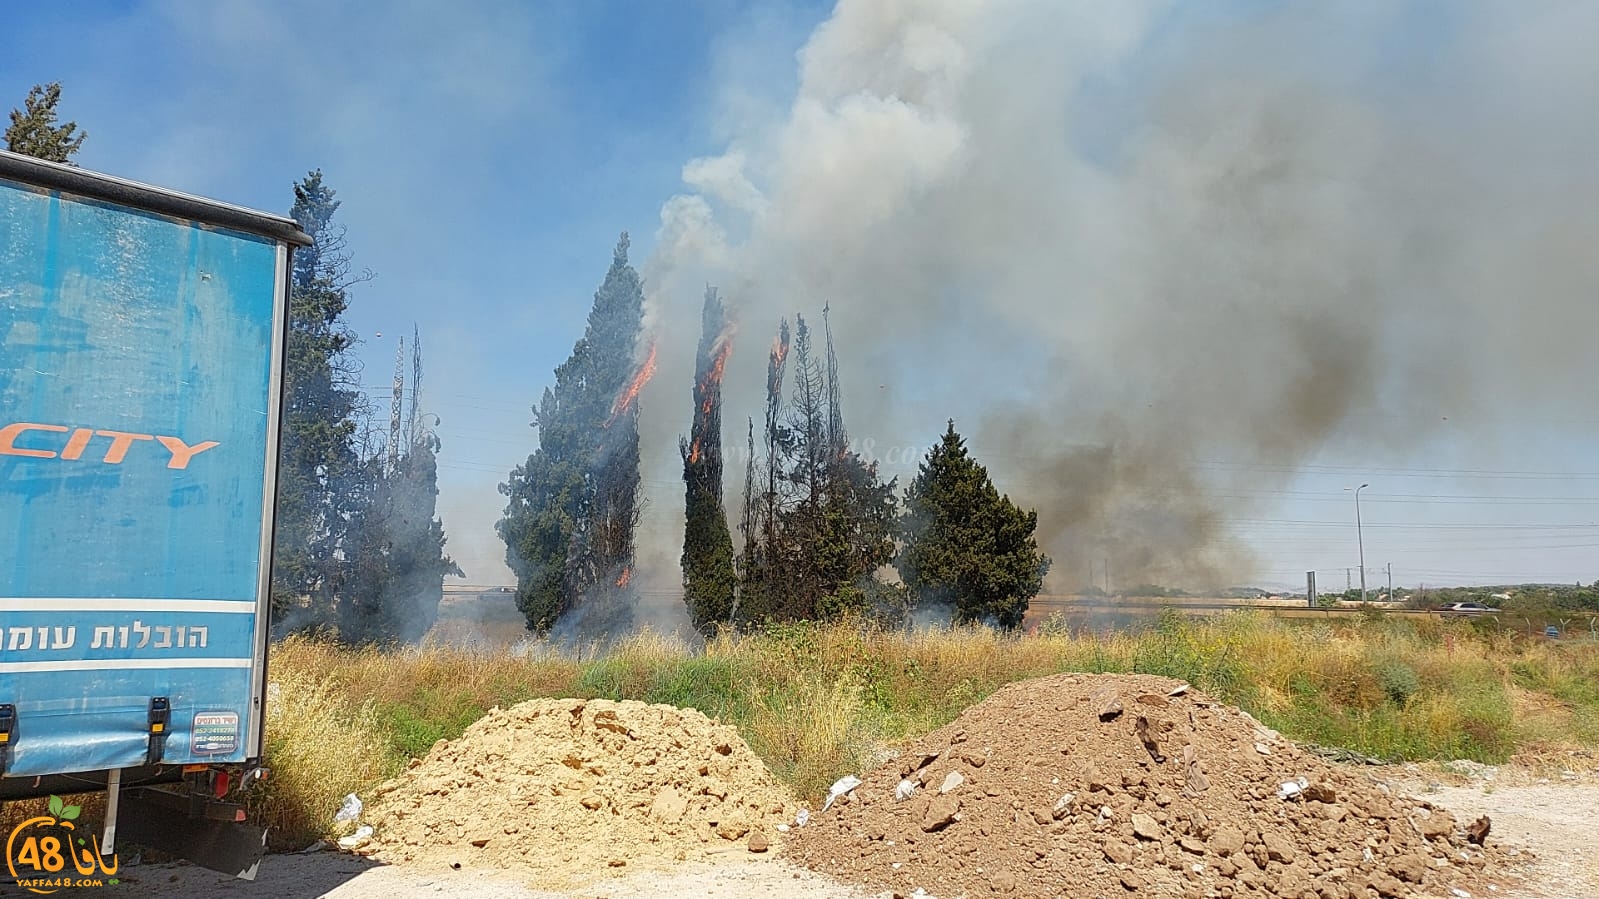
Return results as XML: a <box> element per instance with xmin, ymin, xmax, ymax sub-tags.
<box><xmin>0</xmin><ymin>152</ymin><xmax>310</xmax><ymax>877</ymax></box>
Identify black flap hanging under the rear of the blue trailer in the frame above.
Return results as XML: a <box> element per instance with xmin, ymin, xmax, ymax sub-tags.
<box><xmin>117</xmin><ymin>790</ymin><xmax>267</xmax><ymax>880</ymax></box>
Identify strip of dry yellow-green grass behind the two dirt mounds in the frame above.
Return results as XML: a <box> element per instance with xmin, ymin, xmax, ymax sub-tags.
<box><xmin>236</xmin><ymin>614</ymin><xmax>1599</xmax><ymax>845</ymax></box>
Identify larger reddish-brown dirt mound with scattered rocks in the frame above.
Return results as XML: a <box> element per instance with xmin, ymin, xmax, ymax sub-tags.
<box><xmin>788</xmin><ymin>675</ymin><xmax>1501</xmax><ymax>899</ymax></box>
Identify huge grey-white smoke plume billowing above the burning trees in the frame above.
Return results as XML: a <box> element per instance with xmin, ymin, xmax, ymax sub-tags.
<box><xmin>643</xmin><ymin>0</ymin><xmax>1599</xmax><ymax>589</ymax></box>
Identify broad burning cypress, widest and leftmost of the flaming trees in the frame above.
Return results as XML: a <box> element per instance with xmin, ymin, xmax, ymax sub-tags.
<box><xmin>497</xmin><ymin>232</ymin><xmax>656</xmax><ymax>633</ymax></box>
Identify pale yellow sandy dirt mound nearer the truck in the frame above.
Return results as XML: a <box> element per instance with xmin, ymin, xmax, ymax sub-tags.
<box><xmin>363</xmin><ymin>699</ymin><xmax>793</xmax><ymax>885</ymax></box>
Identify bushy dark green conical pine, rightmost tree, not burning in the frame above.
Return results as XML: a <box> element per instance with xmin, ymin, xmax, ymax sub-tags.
<box><xmin>899</xmin><ymin>421</ymin><xmax>1049</xmax><ymax>629</ymax></box>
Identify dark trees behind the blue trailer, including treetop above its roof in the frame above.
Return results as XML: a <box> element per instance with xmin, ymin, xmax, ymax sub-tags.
<box><xmin>5</xmin><ymin>83</ymin><xmax>461</xmax><ymax>643</ymax></box>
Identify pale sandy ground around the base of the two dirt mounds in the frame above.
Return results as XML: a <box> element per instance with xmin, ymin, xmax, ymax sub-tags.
<box><xmin>99</xmin><ymin>769</ymin><xmax>1599</xmax><ymax>899</ymax></box>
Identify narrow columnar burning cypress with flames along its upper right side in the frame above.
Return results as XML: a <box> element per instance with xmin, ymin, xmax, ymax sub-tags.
<box><xmin>678</xmin><ymin>288</ymin><xmax>737</xmax><ymax>633</ymax></box>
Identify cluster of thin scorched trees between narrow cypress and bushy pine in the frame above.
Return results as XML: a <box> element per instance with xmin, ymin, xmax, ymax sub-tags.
<box><xmin>739</xmin><ymin>303</ymin><xmax>899</xmax><ymax>621</ymax></box>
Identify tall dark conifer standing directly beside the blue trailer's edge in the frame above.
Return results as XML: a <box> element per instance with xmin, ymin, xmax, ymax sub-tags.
<box><xmin>272</xmin><ymin>170</ymin><xmax>371</xmax><ymax>629</ymax></box>
